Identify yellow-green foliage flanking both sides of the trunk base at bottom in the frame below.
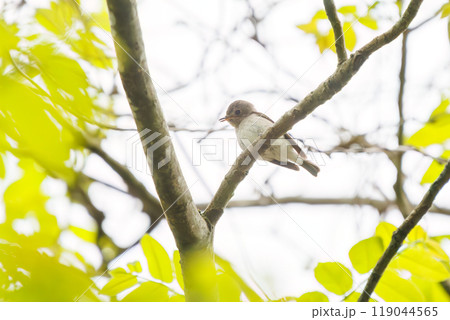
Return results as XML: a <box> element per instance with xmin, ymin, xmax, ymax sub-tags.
<box><xmin>100</xmin><ymin>235</ymin><xmax>263</xmax><ymax>302</ymax></box>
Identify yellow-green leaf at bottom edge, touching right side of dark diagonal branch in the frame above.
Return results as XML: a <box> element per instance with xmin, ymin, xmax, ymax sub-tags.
<box><xmin>375</xmin><ymin>268</ymin><xmax>425</xmax><ymax>302</ymax></box>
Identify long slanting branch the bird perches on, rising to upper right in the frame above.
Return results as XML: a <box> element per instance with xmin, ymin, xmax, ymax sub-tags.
<box><xmin>204</xmin><ymin>0</ymin><xmax>423</xmax><ymax>225</ymax></box>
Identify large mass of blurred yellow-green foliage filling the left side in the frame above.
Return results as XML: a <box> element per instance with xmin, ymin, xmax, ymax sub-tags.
<box><xmin>0</xmin><ymin>0</ymin><xmax>115</xmax><ymax>301</ymax></box>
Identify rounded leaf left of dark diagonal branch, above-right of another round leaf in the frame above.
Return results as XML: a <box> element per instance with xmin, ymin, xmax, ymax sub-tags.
<box><xmin>349</xmin><ymin>237</ymin><xmax>384</xmax><ymax>274</ymax></box>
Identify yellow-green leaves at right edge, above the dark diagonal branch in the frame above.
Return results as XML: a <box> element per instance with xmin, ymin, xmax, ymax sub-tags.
<box><xmin>407</xmin><ymin>96</ymin><xmax>450</xmax><ymax>184</ymax></box>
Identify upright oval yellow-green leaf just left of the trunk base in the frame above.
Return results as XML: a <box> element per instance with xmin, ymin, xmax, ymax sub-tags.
<box><xmin>141</xmin><ymin>234</ymin><xmax>173</xmax><ymax>283</ymax></box>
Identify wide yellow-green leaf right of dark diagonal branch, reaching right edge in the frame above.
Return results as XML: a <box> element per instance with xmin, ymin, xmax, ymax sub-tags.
<box><xmin>392</xmin><ymin>246</ymin><xmax>450</xmax><ymax>282</ymax></box>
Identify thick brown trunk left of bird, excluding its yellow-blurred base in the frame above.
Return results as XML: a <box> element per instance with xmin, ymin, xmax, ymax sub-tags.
<box><xmin>107</xmin><ymin>0</ymin><xmax>210</xmax><ymax>248</ymax></box>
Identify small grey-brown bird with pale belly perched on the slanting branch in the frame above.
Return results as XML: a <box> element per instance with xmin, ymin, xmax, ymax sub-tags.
<box><xmin>219</xmin><ymin>100</ymin><xmax>320</xmax><ymax>177</ymax></box>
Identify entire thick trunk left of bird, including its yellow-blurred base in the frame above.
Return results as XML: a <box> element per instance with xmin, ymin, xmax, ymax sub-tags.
<box><xmin>107</xmin><ymin>0</ymin><xmax>218</xmax><ymax>301</ymax></box>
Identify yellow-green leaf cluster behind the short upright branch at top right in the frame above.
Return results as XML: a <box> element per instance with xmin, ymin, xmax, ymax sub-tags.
<box><xmin>297</xmin><ymin>3</ymin><xmax>378</xmax><ymax>53</ymax></box>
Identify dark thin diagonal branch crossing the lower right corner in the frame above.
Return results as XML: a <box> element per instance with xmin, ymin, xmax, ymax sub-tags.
<box><xmin>358</xmin><ymin>161</ymin><xmax>450</xmax><ymax>302</ymax></box>
